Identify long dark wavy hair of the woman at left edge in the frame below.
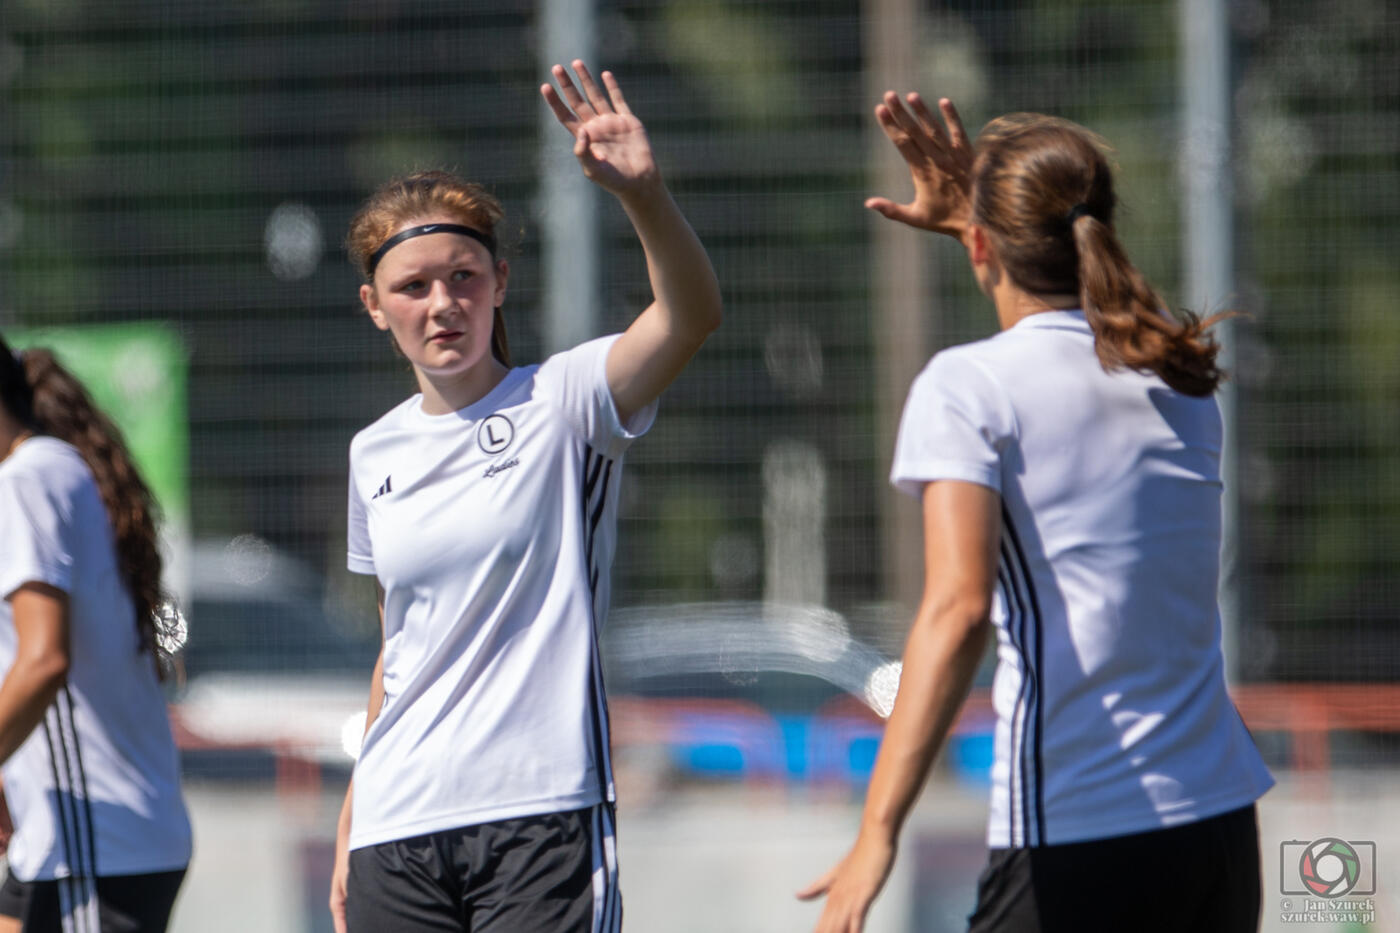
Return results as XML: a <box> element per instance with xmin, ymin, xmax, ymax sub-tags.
<box><xmin>0</xmin><ymin>338</ymin><xmax>171</xmax><ymax>678</ymax></box>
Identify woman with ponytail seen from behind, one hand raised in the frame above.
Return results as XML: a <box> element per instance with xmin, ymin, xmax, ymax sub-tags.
<box><xmin>799</xmin><ymin>92</ymin><xmax>1273</xmax><ymax>933</ymax></box>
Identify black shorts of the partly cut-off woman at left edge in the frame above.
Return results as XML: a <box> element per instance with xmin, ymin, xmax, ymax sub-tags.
<box><xmin>0</xmin><ymin>869</ymin><xmax>185</xmax><ymax>933</ymax></box>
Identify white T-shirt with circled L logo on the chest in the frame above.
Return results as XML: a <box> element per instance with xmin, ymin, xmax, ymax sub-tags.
<box><xmin>349</xmin><ymin>338</ymin><xmax>655</xmax><ymax>849</ymax></box>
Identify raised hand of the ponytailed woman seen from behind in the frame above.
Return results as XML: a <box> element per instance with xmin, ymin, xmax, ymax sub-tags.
<box><xmin>865</xmin><ymin>91</ymin><xmax>974</xmax><ymax>238</ymax></box>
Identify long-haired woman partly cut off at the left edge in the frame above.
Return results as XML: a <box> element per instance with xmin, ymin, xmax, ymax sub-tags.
<box><xmin>0</xmin><ymin>330</ymin><xmax>190</xmax><ymax>933</ymax></box>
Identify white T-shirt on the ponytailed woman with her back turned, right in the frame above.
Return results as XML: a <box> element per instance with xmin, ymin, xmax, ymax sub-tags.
<box><xmin>892</xmin><ymin>311</ymin><xmax>1273</xmax><ymax>846</ymax></box>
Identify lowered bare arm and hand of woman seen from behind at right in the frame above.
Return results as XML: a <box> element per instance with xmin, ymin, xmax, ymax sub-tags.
<box><xmin>798</xmin><ymin>481</ymin><xmax>1001</xmax><ymax>933</ymax></box>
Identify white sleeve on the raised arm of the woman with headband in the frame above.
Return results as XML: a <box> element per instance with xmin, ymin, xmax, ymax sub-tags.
<box><xmin>535</xmin><ymin>333</ymin><xmax>657</xmax><ymax>457</ymax></box>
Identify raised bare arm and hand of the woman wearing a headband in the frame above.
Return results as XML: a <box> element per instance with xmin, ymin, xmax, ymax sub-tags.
<box><xmin>540</xmin><ymin>60</ymin><xmax>721</xmax><ymax>423</ymax></box>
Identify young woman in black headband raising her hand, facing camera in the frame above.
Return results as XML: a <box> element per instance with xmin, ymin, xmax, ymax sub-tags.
<box><xmin>330</xmin><ymin>62</ymin><xmax>720</xmax><ymax>933</ymax></box>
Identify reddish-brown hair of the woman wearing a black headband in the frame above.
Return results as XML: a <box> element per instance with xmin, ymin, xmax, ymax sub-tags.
<box><xmin>346</xmin><ymin>171</ymin><xmax>511</xmax><ymax>367</ymax></box>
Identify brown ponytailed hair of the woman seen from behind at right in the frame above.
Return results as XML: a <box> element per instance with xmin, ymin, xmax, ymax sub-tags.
<box><xmin>972</xmin><ymin>113</ymin><xmax>1232</xmax><ymax>396</ymax></box>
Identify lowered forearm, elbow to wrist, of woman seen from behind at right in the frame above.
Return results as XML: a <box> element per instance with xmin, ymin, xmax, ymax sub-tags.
<box><xmin>861</xmin><ymin>609</ymin><xmax>990</xmax><ymax>842</ymax></box>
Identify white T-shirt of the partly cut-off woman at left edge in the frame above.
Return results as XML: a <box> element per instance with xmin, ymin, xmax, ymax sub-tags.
<box><xmin>0</xmin><ymin>437</ymin><xmax>190</xmax><ymax>881</ymax></box>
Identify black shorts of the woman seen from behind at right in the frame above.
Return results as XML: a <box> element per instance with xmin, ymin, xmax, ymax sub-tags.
<box><xmin>967</xmin><ymin>804</ymin><xmax>1261</xmax><ymax>933</ymax></box>
